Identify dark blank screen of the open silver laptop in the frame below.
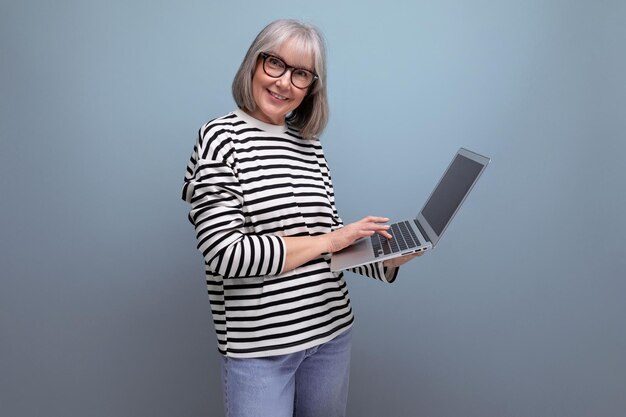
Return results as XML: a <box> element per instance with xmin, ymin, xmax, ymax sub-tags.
<box><xmin>421</xmin><ymin>153</ymin><xmax>485</xmax><ymax>240</ymax></box>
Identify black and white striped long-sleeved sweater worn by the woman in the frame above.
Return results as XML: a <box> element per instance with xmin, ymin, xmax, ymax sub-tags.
<box><xmin>183</xmin><ymin>110</ymin><xmax>397</xmax><ymax>357</ymax></box>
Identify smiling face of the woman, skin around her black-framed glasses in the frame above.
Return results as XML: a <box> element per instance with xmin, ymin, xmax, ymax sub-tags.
<box><xmin>245</xmin><ymin>43</ymin><xmax>313</xmax><ymax>125</ymax></box>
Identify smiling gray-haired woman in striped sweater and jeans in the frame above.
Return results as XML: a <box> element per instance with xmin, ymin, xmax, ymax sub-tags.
<box><xmin>183</xmin><ymin>20</ymin><xmax>414</xmax><ymax>417</ymax></box>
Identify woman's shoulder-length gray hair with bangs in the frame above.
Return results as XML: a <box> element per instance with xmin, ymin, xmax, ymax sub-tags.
<box><xmin>232</xmin><ymin>19</ymin><xmax>329</xmax><ymax>138</ymax></box>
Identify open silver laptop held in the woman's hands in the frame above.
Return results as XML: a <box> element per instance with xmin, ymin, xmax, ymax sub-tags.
<box><xmin>330</xmin><ymin>148</ymin><xmax>490</xmax><ymax>271</ymax></box>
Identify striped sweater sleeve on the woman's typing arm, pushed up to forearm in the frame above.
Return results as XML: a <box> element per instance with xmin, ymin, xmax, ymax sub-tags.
<box><xmin>183</xmin><ymin>124</ymin><xmax>286</xmax><ymax>278</ymax></box>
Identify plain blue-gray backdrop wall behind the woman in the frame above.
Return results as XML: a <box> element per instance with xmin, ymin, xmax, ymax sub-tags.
<box><xmin>0</xmin><ymin>0</ymin><xmax>626</xmax><ymax>417</ymax></box>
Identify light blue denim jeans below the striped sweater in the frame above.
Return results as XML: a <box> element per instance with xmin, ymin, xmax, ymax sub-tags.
<box><xmin>222</xmin><ymin>329</ymin><xmax>352</xmax><ymax>417</ymax></box>
